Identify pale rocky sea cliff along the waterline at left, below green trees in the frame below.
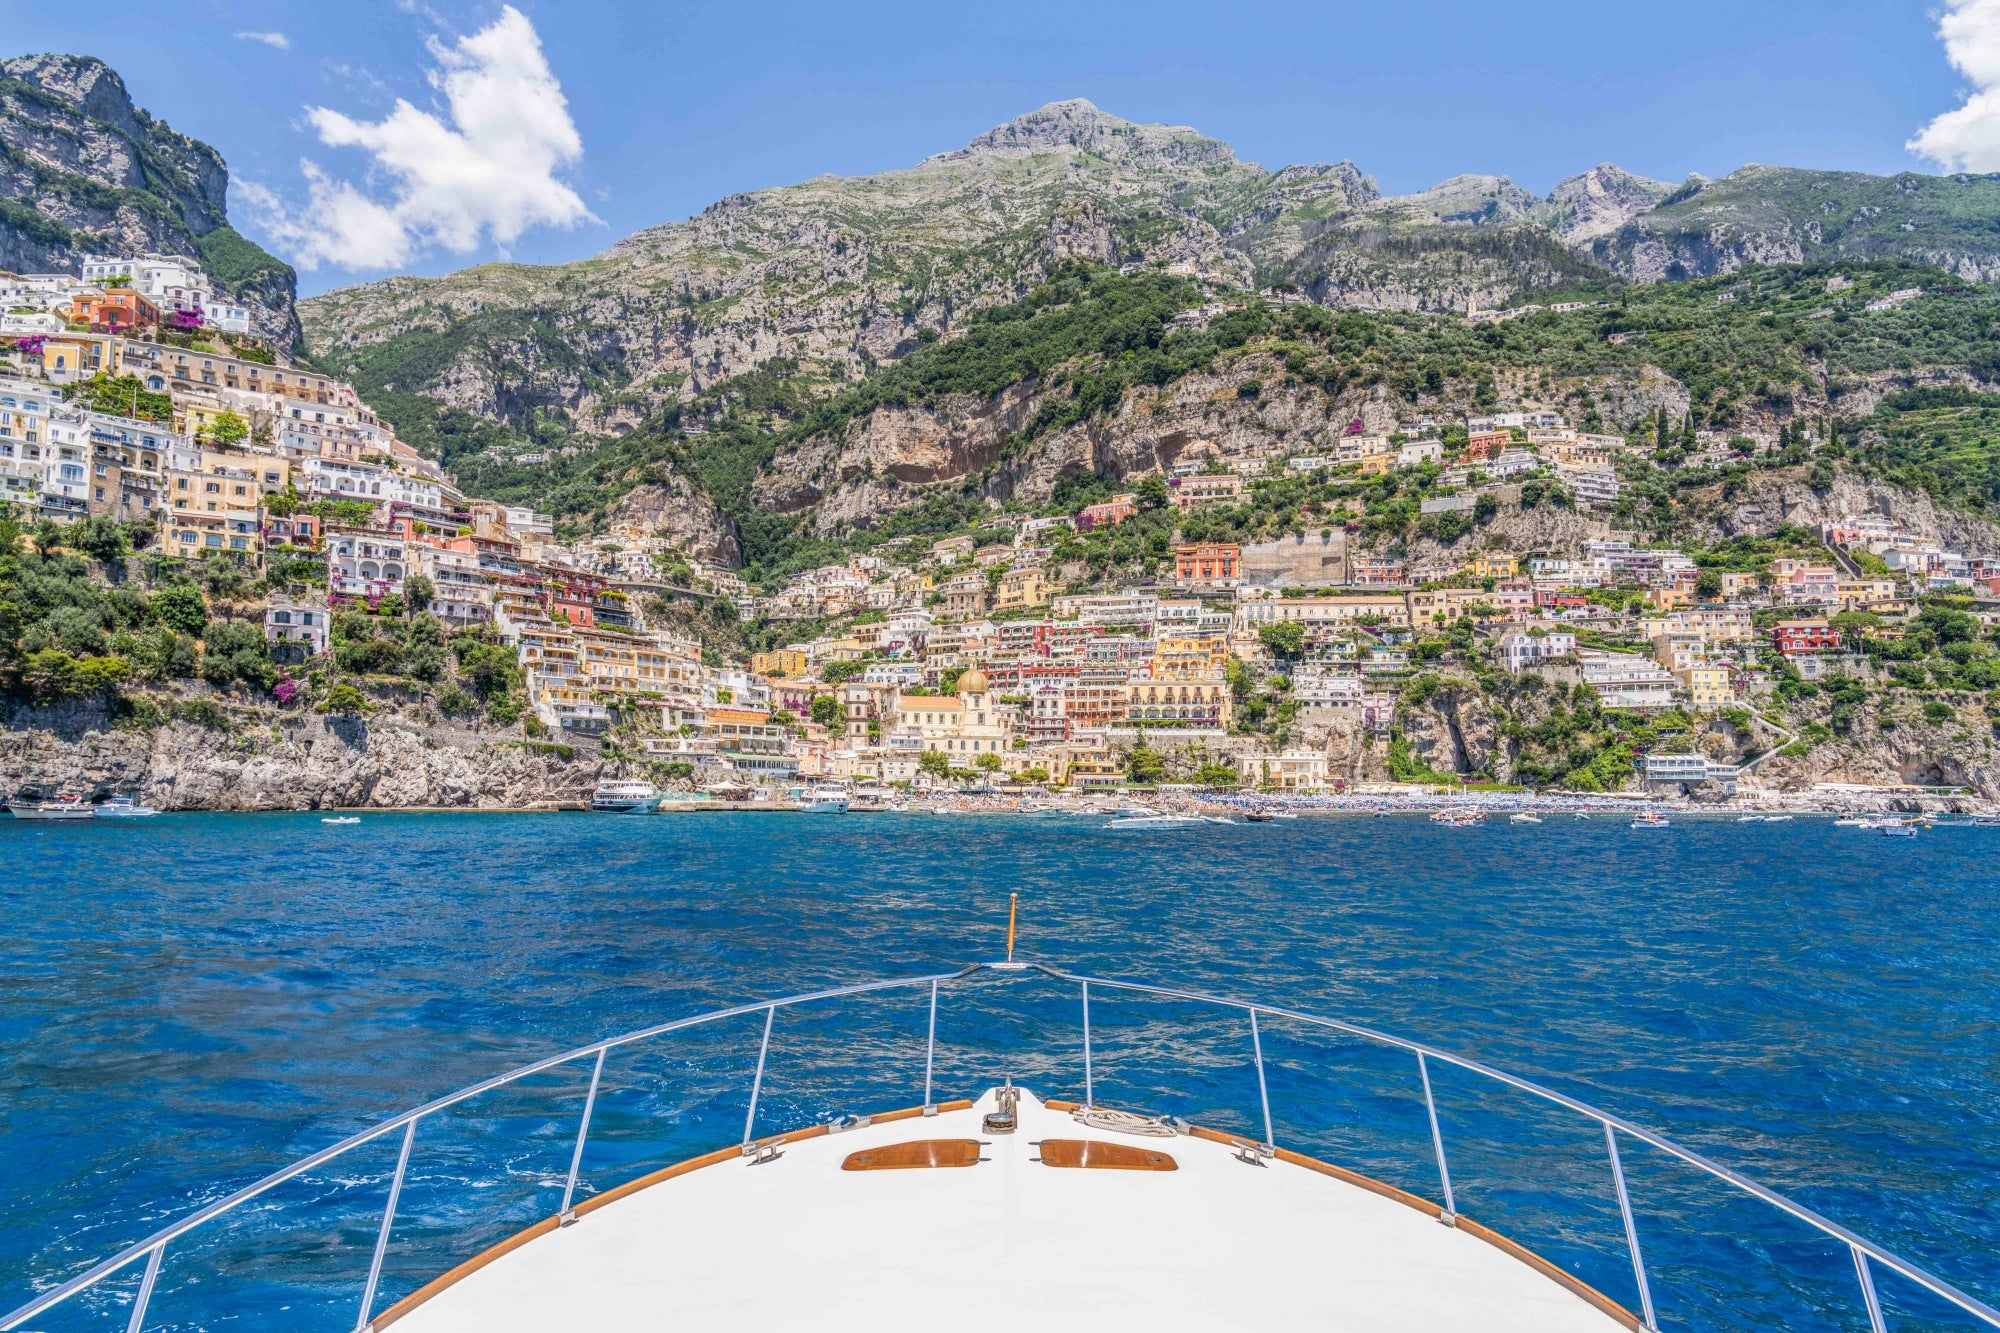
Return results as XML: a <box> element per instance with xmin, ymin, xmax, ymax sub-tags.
<box><xmin>0</xmin><ymin>705</ymin><xmax>616</xmax><ymax>811</ymax></box>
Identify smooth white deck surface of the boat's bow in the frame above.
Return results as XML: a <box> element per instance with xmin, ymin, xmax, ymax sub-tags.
<box><xmin>378</xmin><ymin>1093</ymin><xmax>1622</xmax><ymax>1333</ymax></box>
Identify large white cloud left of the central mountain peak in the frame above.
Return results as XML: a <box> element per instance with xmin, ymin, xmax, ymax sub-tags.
<box><xmin>242</xmin><ymin>6</ymin><xmax>596</xmax><ymax>270</ymax></box>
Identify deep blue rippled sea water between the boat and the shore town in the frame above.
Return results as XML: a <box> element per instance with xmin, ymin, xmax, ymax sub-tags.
<box><xmin>0</xmin><ymin>815</ymin><xmax>2000</xmax><ymax>1331</ymax></box>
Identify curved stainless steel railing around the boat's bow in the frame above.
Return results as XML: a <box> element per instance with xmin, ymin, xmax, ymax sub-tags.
<box><xmin>0</xmin><ymin>961</ymin><xmax>2000</xmax><ymax>1333</ymax></box>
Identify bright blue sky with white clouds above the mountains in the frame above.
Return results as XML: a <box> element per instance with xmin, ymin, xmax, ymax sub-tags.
<box><xmin>11</xmin><ymin>0</ymin><xmax>2000</xmax><ymax>294</ymax></box>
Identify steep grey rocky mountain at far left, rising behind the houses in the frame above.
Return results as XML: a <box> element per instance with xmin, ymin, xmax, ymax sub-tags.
<box><xmin>0</xmin><ymin>56</ymin><xmax>300</xmax><ymax>350</ymax></box>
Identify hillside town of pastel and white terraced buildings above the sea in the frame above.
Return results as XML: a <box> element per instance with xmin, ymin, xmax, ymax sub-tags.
<box><xmin>0</xmin><ymin>254</ymin><xmax>2000</xmax><ymax>793</ymax></box>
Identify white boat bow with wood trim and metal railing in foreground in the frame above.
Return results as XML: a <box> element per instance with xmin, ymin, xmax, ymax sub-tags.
<box><xmin>0</xmin><ymin>959</ymin><xmax>2000</xmax><ymax>1333</ymax></box>
